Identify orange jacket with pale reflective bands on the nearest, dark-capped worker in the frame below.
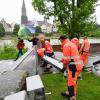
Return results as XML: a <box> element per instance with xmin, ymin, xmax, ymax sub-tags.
<box><xmin>61</xmin><ymin>41</ymin><xmax>83</xmax><ymax>71</ymax></box>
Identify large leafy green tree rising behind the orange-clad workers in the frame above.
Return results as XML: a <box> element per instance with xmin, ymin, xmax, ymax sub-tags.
<box><xmin>32</xmin><ymin>0</ymin><xmax>98</xmax><ymax>38</ymax></box>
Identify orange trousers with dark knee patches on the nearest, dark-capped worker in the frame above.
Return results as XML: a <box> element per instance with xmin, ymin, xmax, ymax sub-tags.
<box><xmin>67</xmin><ymin>71</ymin><xmax>81</xmax><ymax>97</ymax></box>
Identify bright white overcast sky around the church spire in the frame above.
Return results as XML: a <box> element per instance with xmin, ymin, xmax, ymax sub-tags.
<box><xmin>0</xmin><ymin>0</ymin><xmax>100</xmax><ymax>24</ymax></box>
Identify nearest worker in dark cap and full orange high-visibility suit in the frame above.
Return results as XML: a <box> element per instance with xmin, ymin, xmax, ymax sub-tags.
<box><xmin>59</xmin><ymin>35</ymin><xmax>83</xmax><ymax>100</ymax></box>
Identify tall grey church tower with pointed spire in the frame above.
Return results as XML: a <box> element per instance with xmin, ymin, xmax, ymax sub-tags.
<box><xmin>21</xmin><ymin>0</ymin><xmax>28</xmax><ymax>25</ymax></box>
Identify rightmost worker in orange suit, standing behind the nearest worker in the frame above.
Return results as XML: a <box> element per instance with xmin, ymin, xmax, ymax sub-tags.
<box><xmin>79</xmin><ymin>36</ymin><xmax>90</xmax><ymax>66</ymax></box>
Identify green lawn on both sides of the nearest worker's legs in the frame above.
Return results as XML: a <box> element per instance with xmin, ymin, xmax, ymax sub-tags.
<box><xmin>42</xmin><ymin>72</ymin><xmax>100</xmax><ymax>100</ymax></box>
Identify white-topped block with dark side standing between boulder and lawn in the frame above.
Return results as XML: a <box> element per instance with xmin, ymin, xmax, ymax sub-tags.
<box><xmin>26</xmin><ymin>75</ymin><xmax>46</xmax><ymax>100</ymax></box>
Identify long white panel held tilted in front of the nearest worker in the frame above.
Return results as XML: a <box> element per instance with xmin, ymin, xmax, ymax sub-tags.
<box><xmin>43</xmin><ymin>56</ymin><xmax>63</xmax><ymax>70</ymax></box>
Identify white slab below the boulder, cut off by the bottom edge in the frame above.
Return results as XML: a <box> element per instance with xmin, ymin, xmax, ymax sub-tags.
<box><xmin>4</xmin><ymin>91</ymin><xmax>29</xmax><ymax>100</ymax></box>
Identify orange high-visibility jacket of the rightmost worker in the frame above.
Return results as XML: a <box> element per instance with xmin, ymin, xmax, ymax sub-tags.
<box><xmin>80</xmin><ymin>39</ymin><xmax>90</xmax><ymax>53</ymax></box>
